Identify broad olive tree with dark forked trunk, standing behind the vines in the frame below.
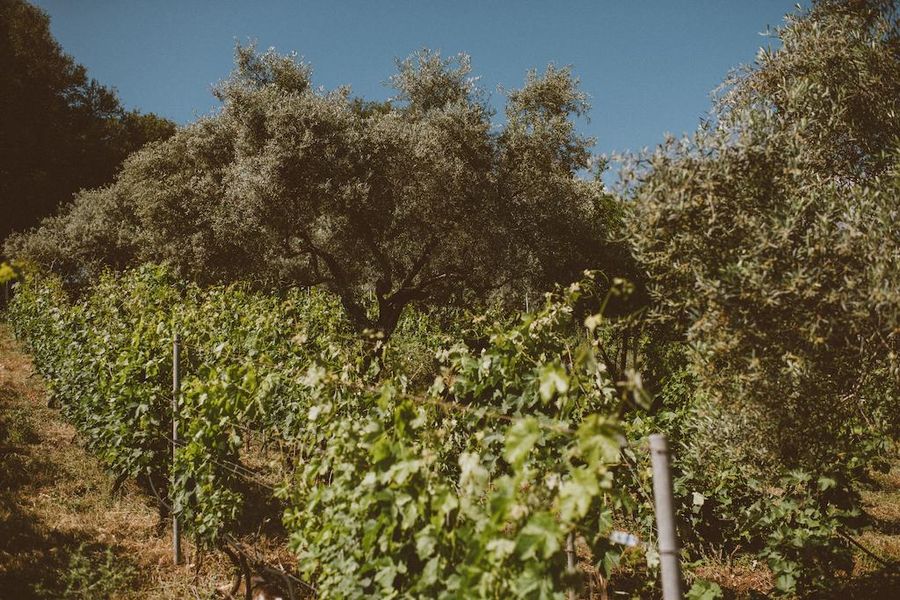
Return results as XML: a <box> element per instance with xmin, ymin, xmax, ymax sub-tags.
<box><xmin>14</xmin><ymin>47</ymin><xmax>623</xmax><ymax>335</ymax></box>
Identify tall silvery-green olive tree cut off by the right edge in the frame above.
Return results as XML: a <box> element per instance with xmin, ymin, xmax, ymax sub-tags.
<box><xmin>628</xmin><ymin>0</ymin><xmax>900</xmax><ymax>469</ymax></box>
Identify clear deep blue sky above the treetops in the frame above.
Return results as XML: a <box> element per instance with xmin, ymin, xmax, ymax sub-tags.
<box><xmin>35</xmin><ymin>0</ymin><xmax>795</xmax><ymax>158</ymax></box>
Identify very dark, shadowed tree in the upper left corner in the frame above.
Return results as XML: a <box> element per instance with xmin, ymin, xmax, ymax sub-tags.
<box><xmin>0</xmin><ymin>0</ymin><xmax>175</xmax><ymax>240</ymax></box>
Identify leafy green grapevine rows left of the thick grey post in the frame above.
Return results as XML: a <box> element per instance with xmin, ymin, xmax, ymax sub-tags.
<box><xmin>11</xmin><ymin>267</ymin><xmax>648</xmax><ymax>597</ymax></box>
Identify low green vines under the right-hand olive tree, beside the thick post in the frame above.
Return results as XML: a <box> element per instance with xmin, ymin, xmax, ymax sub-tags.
<box><xmin>619</xmin><ymin>364</ymin><xmax>864</xmax><ymax>596</ymax></box>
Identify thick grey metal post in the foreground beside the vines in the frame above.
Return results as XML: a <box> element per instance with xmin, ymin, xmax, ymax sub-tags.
<box><xmin>650</xmin><ymin>434</ymin><xmax>681</xmax><ymax>600</ymax></box>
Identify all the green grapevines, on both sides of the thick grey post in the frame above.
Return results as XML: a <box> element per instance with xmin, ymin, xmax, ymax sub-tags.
<box><xmin>1</xmin><ymin>267</ymin><xmax>892</xmax><ymax>597</ymax></box>
